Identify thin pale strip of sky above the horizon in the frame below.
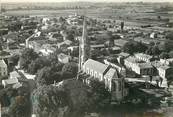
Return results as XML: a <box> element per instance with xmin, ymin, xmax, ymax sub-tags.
<box><xmin>0</xmin><ymin>0</ymin><xmax>173</xmax><ymax>2</ymax></box>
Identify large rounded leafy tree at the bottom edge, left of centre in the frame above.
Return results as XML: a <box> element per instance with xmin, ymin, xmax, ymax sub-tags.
<box><xmin>31</xmin><ymin>85</ymin><xmax>68</xmax><ymax>117</ymax></box>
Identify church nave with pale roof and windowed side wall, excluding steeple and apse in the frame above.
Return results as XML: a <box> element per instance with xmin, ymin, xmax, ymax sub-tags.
<box><xmin>83</xmin><ymin>59</ymin><xmax>109</xmax><ymax>81</ymax></box>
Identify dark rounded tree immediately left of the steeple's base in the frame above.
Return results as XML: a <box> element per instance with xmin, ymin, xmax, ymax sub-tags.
<box><xmin>62</xmin><ymin>62</ymin><xmax>78</xmax><ymax>77</ymax></box>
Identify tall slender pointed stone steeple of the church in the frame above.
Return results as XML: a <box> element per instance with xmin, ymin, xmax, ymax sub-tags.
<box><xmin>79</xmin><ymin>16</ymin><xmax>90</xmax><ymax>71</ymax></box>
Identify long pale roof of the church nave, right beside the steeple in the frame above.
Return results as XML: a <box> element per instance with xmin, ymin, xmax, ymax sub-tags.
<box><xmin>84</xmin><ymin>59</ymin><xmax>108</xmax><ymax>73</ymax></box>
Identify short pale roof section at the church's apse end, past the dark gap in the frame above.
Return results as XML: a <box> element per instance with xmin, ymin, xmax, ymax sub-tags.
<box><xmin>104</xmin><ymin>68</ymin><xmax>118</xmax><ymax>79</ymax></box>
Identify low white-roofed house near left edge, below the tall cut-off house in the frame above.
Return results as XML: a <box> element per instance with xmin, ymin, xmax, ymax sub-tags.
<box><xmin>2</xmin><ymin>78</ymin><xmax>19</xmax><ymax>88</ymax></box>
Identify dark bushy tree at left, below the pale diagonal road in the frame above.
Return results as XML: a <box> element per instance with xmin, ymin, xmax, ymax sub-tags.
<box><xmin>19</xmin><ymin>48</ymin><xmax>38</xmax><ymax>70</ymax></box>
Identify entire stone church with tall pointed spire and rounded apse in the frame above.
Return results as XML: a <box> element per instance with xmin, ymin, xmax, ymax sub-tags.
<box><xmin>78</xmin><ymin>17</ymin><xmax>128</xmax><ymax>102</ymax></box>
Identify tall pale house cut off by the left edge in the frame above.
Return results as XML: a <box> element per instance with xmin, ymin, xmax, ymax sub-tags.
<box><xmin>0</xmin><ymin>59</ymin><xmax>8</xmax><ymax>77</ymax></box>
